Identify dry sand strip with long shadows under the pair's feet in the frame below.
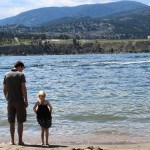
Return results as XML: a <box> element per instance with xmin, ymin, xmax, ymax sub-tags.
<box><xmin>0</xmin><ymin>143</ymin><xmax>150</xmax><ymax>150</ymax></box>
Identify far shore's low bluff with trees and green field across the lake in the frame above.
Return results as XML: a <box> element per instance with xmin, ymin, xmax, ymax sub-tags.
<box><xmin>0</xmin><ymin>39</ymin><xmax>150</xmax><ymax>56</ymax></box>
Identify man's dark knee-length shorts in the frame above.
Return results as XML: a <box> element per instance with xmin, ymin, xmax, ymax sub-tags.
<box><xmin>7</xmin><ymin>102</ymin><xmax>27</xmax><ymax>123</ymax></box>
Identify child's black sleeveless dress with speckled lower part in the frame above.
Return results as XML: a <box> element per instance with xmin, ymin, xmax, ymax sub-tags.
<box><xmin>37</xmin><ymin>104</ymin><xmax>52</xmax><ymax>129</ymax></box>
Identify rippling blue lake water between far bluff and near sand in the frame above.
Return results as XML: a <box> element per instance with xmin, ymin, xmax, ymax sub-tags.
<box><xmin>0</xmin><ymin>54</ymin><xmax>150</xmax><ymax>144</ymax></box>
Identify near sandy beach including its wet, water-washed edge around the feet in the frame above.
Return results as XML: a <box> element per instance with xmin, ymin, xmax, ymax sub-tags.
<box><xmin>0</xmin><ymin>133</ymin><xmax>150</xmax><ymax>150</ymax></box>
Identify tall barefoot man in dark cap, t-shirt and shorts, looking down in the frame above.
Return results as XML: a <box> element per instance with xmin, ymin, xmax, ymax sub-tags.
<box><xmin>3</xmin><ymin>61</ymin><xmax>28</xmax><ymax>145</ymax></box>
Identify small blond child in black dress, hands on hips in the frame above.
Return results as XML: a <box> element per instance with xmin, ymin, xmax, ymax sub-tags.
<box><xmin>33</xmin><ymin>91</ymin><xmax>52</xmax><ymax>145</ymax></box>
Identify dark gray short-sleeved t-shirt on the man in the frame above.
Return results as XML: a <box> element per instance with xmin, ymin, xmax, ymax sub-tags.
<box><xmin>3</xmin><ymin>69</ymin><xmax>26</xmax><ymax>103</ymax></box>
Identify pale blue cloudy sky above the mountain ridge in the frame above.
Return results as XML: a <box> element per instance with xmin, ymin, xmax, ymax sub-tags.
<box><xmin>0</xmin><ymin>0</ymin><xmax>150</xmax><ymax>20</ymax></box>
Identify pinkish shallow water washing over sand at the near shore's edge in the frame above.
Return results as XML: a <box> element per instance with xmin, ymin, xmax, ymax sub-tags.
<box><xmin>0</xmin><ymin>131</ymin><xmax>150</xmax><ymax>145</ymax></box>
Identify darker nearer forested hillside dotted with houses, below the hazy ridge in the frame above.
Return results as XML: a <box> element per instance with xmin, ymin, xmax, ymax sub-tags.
<box><xmin>0</xmin><ymin>3</ymin><xmax>150</xmax><ymax>39</ymax></box>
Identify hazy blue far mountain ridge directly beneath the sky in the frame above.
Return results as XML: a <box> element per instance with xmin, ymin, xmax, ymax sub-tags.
<box><xmin>0</xmin><ymin>1</ymin><xmax>148</xmax><ymax>27</ymax></box>
